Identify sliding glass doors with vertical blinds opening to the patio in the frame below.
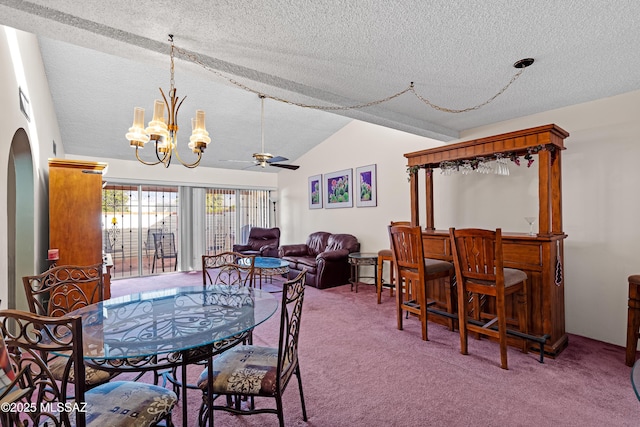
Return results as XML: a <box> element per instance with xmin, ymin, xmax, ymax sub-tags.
<box><xmin>102</xmin><ymin>184</ymin><xmax>271</xmax><ymax>279</ymax></box>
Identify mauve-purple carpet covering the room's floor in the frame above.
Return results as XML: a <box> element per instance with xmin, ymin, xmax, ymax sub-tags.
<box><xmin>112</xmin><ymin>272</ymin><xmax>640</xmax><ymax>427</ymax></box>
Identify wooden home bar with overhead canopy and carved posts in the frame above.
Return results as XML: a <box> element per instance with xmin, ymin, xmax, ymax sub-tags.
<box><xmin>405</xmin><ymin>124</ymin><xmax>569</xmax><ymax>357</ymax></box>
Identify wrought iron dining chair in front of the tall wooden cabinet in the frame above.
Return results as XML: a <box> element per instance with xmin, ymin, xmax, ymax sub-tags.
<box><xmin>22</xmin><ymin>263</ymin><xmax>117</xmax><ymax>388</ymax></box>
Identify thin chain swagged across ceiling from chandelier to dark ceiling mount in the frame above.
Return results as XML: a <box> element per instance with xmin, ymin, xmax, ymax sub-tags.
<box><xmin>171</xmin><ymin>44</ymin><xmax>526</xmax><ymax>114</ymax></box>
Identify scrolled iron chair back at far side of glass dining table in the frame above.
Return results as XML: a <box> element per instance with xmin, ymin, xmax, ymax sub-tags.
<box><xmin>202</xmin><ymin>252</ymin><xmax>255</xmax><ymax>286</ymax></box>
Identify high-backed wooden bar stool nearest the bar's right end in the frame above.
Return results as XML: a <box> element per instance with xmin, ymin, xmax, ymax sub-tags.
<box><xmin>449</xmin><ymin>228</ymin><xmax>529</xmax><ymax>369</ymax></box>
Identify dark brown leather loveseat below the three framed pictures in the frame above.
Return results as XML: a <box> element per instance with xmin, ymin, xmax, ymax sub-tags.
<box><xmin>278</xmin><ymin>231</ymin><xmax>360</xmax><ymax>289</ymax></box>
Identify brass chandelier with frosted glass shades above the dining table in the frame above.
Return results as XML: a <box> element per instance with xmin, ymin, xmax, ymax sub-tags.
<box><xmin>126</xmin><ymin>34</ymin><xmax>211</xmax><ymax>168</ymax></box>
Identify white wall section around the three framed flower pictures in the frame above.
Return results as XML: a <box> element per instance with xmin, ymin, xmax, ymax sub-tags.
<box><xmin>278</xmin><ymin>120</ymin><xmax>446</xmax><ymax>253</ymax></box>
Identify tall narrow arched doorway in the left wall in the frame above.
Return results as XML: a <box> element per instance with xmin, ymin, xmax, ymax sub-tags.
<box><xmin>7</xmin><ymin>129</ymin><xmax>34</xmax><ymax>311</ymax></box>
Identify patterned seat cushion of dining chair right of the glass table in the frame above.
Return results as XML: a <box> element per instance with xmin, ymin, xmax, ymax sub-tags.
<box><xmin>197</xmin><ymin>345</ymin><xmax>278</xmax><ymax>396</ymax></box>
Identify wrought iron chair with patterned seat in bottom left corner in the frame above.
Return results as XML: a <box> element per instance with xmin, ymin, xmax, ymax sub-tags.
<box><xmin>0</xmin><ymin>310</ymin><xmax>177</xmax><ymax>427</ymax></box>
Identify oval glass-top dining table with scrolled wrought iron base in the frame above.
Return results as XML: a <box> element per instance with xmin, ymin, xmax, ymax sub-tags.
<box><xmin>69</xmin><ymin>285</ymin><xmax>278</xmax><ymax>426</ymax></box>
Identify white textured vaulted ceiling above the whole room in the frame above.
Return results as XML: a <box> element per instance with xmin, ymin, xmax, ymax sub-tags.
<box><xmin>0</xmin><ymin>0</ymin><xmax>640</xmax><ymax>172</ymax></box>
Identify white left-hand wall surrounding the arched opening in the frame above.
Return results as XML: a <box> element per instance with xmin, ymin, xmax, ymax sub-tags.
<box><xmin>0</xmin><ymin>26</ymin><xmax>60</xmax><ymax>308</ymax></box>
